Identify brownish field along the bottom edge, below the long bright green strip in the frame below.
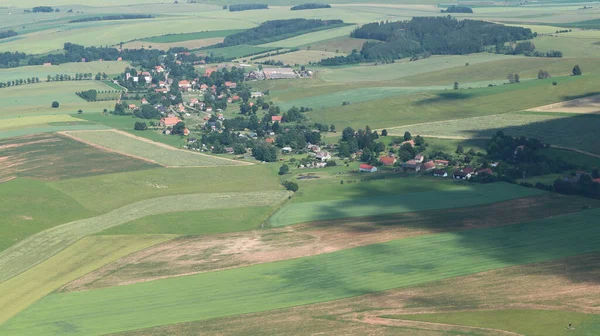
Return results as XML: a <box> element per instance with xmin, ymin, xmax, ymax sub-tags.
<box><xmin>111</xmin><ymin>253</ymin><xmax>600</xmax><ymax>336</ymax></box>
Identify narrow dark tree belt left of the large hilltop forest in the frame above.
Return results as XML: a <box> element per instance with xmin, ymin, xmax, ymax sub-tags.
<box><xmin>218</xmin><ymin>19</ymin><xmax>344</xmax><ymax>48</ymax></box>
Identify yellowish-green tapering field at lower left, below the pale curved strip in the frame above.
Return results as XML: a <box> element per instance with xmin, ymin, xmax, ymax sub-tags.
<box><xmin>0</xmin><ymin>235</ymin><xmax>173</xmax><ymax>323</ymax></box>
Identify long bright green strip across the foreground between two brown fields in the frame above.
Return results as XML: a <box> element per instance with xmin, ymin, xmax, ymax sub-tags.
<box><xmin>0</xmin><ymin>210</ymin><xmax>600</xmax><ymax>335</ymax></box>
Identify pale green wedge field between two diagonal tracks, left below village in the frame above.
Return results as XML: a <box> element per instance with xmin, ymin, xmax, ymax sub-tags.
<box><xmin>62</xmin><ymin>131</ymin><xmax>244</xmax><ymax>167</ymax></box>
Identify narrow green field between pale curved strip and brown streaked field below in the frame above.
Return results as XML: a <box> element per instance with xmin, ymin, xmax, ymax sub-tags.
<box><xmin>98</xmin><ymin>207</ymin><xmax>272</xmax><ymax>235</ymax></box>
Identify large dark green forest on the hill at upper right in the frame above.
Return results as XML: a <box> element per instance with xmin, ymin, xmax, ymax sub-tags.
<box><xmin>321</xmin><ymin>16</ymin><xmax>535</xmax><ymax>65</ymax></box>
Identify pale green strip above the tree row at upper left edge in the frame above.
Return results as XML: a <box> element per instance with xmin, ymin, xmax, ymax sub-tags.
<box><xmin>0</xmin><ymin>61</ymin><xmax>130</xmax><ymax>82</ymax></box>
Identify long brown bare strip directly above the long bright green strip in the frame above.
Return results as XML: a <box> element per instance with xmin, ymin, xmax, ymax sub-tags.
<box><xmin>61</xmin><ymin>194</ymin><xmax>600</xmax><ymax>291</ymax></box>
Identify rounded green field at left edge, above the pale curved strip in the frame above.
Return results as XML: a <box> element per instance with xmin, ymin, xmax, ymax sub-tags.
<box><xmin>0</xmin><ymin>178</ymin><xmax>95</xmax><ymax>251</ymax></box>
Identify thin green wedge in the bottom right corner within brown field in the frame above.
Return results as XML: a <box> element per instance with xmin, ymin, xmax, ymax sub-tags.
<box><xmin>386</xmin><ymin>310</ymin><xmax>600</xmax><ymax>336</ymax></box>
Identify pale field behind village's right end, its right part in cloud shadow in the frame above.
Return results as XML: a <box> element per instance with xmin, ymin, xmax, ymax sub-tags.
<box><xmin>388</xmin><ymin>112</ymin><xmax>600</xmax><ymax>154</ymax></box>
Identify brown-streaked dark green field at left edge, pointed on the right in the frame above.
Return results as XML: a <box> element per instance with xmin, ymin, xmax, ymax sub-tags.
<box><xmin>0</xmin><ymin>133</ymin><xmax>158</xmax><ymax>180</ymax></box>
